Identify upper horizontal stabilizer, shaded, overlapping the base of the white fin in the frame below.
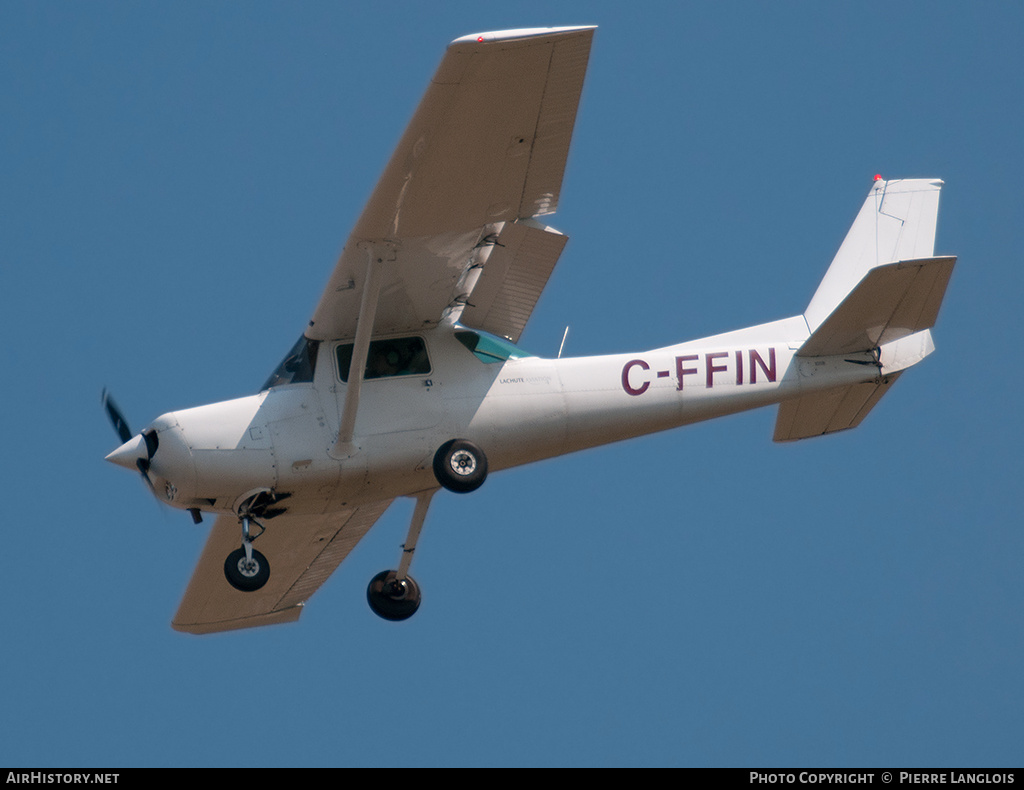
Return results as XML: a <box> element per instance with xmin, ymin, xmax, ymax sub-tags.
<box><xmin>798</xmin><ymin>257</ymin><xmax>956</xmax><ymax>357</ymax></box>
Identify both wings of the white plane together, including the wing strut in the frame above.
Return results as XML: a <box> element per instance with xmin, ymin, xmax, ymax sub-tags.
<box><xmin>172</xmin><ymin>28</ymin><xmax>594</xmax><ymax>633</ymax></box>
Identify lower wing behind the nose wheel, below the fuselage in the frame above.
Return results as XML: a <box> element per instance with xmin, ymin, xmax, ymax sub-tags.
<box><xmin>171</xmin><ymin>500</ymin><xmax>393</xmax><ymax>633</ymax></box>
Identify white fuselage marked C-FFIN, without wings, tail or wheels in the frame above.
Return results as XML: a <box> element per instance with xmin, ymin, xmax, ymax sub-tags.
<box><xmin>121</xmin><ymin>317</ymin><xmax>880</xmax><ymax>522</ymax></box>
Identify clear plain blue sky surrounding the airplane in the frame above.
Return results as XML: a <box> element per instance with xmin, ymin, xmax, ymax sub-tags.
<box><xmin>0</xmin><ymin>2</ymin><xmax>1024</xmax><ymax>766</ymax></box>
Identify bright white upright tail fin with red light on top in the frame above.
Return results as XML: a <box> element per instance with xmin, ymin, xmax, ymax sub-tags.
<box><xmin>804</xmin><ymin>178</ymin><xmax>942</xmax><ymax>333</ymax></box>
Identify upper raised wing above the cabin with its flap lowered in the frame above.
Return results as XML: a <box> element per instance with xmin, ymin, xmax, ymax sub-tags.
<box><xmin>305</xmin><ymin>28</ymin><xmax>594</xmax><ymax>340</ymax></box>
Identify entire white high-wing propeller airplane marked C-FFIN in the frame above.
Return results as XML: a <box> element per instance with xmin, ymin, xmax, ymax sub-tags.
<box><xmin>103</xmin><ymin>27</ymin><xmax>956</xmax><ymax>633</ymax></box>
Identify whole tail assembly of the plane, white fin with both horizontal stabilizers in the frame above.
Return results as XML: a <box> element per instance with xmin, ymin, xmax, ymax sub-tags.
<box><xmin>774</xmin><ymin>179</ymin><xmax>956</xmax><ymax>442</ymax></box>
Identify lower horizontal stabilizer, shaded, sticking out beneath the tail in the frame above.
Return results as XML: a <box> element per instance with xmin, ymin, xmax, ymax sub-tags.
<box><xmin>772</xmin><ymin>373</ymin><xmax>900</xmax><ymax>442</ymax></box>
